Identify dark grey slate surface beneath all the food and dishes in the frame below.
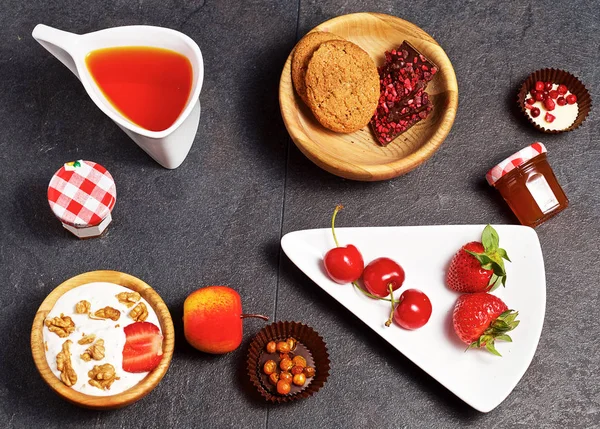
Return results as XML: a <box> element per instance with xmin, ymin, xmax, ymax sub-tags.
<box><xmin>0</xmin><ymin>0</ymin><xmax>600</xmax><ymax>429</ymax></box>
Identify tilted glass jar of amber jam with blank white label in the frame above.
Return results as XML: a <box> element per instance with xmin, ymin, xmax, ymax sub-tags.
<box><xmin>486</xmin><ymin>142</ymin><xmax>569</xmax><ymax>227</ymax></box>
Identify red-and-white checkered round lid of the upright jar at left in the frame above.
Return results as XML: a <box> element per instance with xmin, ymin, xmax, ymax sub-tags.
<box><xmin>48</xmin><ymin>161</ymin><xmax>117</xmax><ymax>228</ymax></box>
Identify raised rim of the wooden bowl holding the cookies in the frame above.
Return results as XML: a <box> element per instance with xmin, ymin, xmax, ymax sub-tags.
<box><xmin>279</xmin><ymin>12</ymin><xmax>458</xmax><ymax>181</ymax></box>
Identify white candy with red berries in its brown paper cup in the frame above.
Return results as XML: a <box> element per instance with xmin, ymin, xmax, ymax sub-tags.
<box><xmin>517</xmin><ymin>69</ymin><xmax>592</xmax><ymax>134</ymax></box>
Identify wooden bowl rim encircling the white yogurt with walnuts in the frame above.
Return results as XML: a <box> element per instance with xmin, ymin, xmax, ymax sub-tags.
<box><xmin>31</xmin><ymin>271</ymin><xmax>175</xmax><ymax>410</ymax></box>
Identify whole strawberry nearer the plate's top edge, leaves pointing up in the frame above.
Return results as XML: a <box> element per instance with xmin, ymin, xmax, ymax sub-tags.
<box><xmin>446</xmin><ymin>225</ymin><xmax>510</xmax><ymax>293</ymax></box>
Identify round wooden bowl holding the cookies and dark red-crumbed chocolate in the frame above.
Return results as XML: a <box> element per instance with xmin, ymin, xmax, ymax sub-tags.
<box><xmin>279</xmin><ymin>13</ymin><xmax>458</xmax><ymax>181</ymax></box>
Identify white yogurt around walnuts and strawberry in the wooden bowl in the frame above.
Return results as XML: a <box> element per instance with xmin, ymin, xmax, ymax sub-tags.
<box><xmin>43</xmin><ymin>282</ymin><xmax>162</xmax><ymax>396</ymax></box>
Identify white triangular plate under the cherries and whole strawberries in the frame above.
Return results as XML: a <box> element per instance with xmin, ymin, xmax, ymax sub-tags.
<box><xmin>281</xmin><ymin>225</ymin><xmax>546</xmax><ymax>412</ymax></box>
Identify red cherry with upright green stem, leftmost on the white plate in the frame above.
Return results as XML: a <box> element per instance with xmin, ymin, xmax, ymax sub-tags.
<box><xmin>323</xmin><ymin>205</ymin><xmax>365</xmax><ymax>284</ymax></box>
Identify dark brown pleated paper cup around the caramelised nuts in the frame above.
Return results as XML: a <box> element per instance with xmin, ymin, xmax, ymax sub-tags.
<box><xmin>247</xmin><ymin>322</ymin><xmax>330</xmax><ymax>403</ymax></box>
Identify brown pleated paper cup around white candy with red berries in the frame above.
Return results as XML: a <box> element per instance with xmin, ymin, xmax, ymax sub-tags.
<box><xmin>517</xmin><ymin>69</ymin><xmax>592</xmax><ymax>134</ymax></box>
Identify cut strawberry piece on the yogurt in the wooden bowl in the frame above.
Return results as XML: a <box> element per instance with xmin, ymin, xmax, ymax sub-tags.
<box><xmin>123</xmin><ymin>322</ymin><xmax>163</xmax><ymax>372</ymax></box>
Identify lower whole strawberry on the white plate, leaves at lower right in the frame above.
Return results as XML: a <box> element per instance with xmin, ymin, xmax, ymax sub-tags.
<box><xmin>452</xmin><ymin>292</ymin><xmax>519</xmax><ymax>356</ymax></box>
